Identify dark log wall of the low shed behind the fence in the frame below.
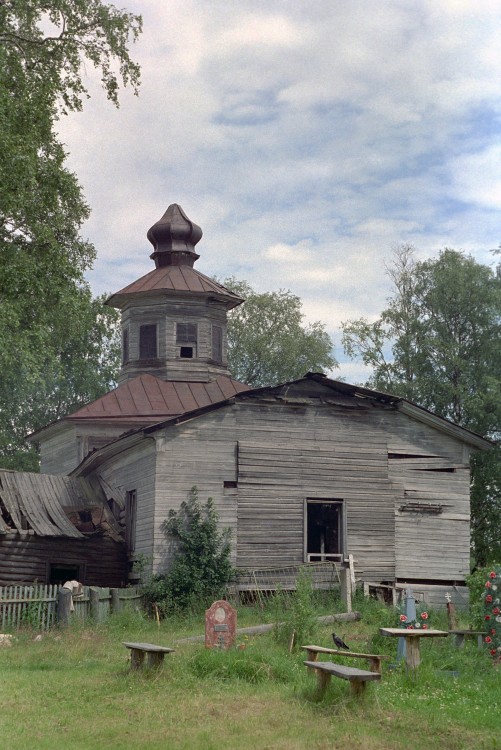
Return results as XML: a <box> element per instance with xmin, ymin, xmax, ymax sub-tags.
<box><xmin>0</xmin><ymin>533</ymin><xmax>128</xmax><ymax>586</ymax></box>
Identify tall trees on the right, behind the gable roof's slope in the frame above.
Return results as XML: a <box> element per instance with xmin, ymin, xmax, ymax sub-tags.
<box><xmin>343</xmin><ymin>245</ymin><xmax>501</xmax><ymax>565</ymax></box>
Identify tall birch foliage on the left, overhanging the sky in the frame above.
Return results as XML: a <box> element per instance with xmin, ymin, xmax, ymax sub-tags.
<box><xmin>0</xmin><ymin>0</ymin><xmax>141</xmax><ymax>470</ymax></box>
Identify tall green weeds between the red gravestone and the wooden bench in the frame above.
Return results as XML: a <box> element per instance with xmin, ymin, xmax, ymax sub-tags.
<box><xmin>273</xmin><ymin>568</ymin><xmax>318</xmax><ymax>646</ymax></box>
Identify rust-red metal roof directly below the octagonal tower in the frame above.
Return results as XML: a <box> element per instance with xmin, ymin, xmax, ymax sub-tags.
<box><xmin>65</xmin><ymin>374</ymin><xmax>249</xmax><ymax>424</ymax></box>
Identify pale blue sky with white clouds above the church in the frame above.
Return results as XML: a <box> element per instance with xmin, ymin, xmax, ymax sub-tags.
<box><xmin>55</xmin><ymin>0</ymin><xmax>501</xmax><ymax>383</ymax></box>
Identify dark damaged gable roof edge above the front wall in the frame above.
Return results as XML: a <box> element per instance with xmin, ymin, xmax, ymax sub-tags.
<box><xmin>72</xmin><ymin>373</ymin><xmax>493</xmax><ymax>476</ymax></box>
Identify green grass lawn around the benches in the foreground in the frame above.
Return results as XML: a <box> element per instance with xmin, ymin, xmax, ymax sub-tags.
<box><xmin>0</xmin><ymin>602</ymin><xmax>501</xmax><ymax>750</ymax></box>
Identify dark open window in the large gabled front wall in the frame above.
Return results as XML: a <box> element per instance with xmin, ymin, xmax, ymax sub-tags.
<box><xmin>305</xmin><ymin>500</ymin><xmax>344</xmax><ymax>562</ymax></box>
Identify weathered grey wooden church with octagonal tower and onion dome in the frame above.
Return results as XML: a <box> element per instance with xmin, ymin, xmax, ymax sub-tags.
<box><xmin>13</xmin><ymin>204</ymin><xmax>490</xmax><ymax>603</ymax></box>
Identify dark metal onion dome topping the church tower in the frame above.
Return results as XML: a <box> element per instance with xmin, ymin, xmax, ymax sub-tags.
<box><xmin>146</xmin><ymin>203</ymin><xmax>202</xmax><ymax>268</ymax></box>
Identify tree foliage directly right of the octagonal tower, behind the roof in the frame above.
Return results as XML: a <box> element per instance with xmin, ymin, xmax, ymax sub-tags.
<box><xmin>222</xmin><ymin>278</ymin><xmax>337</xmax><ymax>387</ymax></box>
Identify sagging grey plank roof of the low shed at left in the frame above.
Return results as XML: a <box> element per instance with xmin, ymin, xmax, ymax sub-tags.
<box><xmin>0</xmin><ymin>470</ymin><xmax>123</xmax><ymax>541</ymax></box>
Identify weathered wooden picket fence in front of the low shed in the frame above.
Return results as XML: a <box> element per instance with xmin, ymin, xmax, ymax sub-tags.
<box><xmin>0</xmin><ymin>585</ymin><xmax>141</xmax><ymax>633</ymax></box>
